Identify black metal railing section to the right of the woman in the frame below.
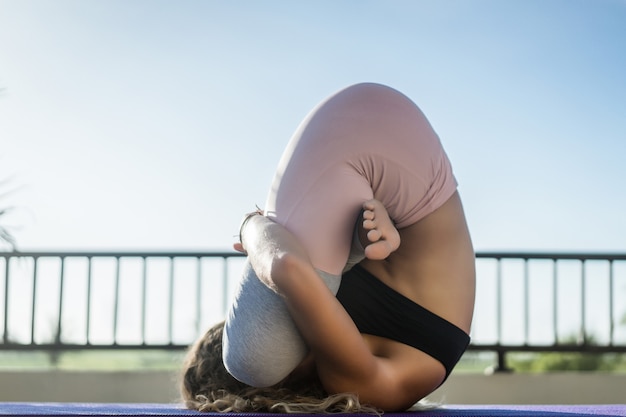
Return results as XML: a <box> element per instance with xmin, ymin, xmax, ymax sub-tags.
<box><xmin>469</xmin><ymin>252</ymin><xmax>626</xmax><ymax>370</ymax></box>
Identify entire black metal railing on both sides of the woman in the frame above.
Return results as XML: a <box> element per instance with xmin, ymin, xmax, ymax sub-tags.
<box><xmin>0</xmin><ymin>252</ymin><xmax>626</xmax><ymax>369</ymax></box>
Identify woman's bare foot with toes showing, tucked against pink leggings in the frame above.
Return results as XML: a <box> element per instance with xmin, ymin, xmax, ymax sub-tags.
<box><xmin>363</xmin><ymin>199</ymin><xmax>400</xmax><ymax>260</ymax></box>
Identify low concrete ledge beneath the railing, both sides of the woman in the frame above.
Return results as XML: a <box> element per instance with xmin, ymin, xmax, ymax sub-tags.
<box><xmin>0</xmin><ymin>371</ymin><xmax>626</xmax><ymax>404</ymax></box>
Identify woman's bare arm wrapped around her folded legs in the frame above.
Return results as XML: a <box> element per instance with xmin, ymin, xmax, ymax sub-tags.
<box><xmin>238</xmin><ymin>216</ymin><xmax>434</xmax><ymax>410</ymax></box>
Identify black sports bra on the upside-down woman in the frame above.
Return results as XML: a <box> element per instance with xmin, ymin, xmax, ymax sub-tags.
<box><xmin>337</xmin><ymin>265</ymin><xmax>470</xmax><ymax>378</ymax></box>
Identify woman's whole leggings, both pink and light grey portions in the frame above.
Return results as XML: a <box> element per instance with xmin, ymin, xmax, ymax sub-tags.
<box><xmin>223</xmin><ymin>84</ymin><xmax>456</xmax><ymax>387</ymax></box>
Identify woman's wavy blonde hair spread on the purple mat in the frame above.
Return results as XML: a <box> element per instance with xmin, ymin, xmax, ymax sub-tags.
<box><xmin>181</xmin><ymin>322</ymin><xmax>382</xmax><ymax>415</ymax></box>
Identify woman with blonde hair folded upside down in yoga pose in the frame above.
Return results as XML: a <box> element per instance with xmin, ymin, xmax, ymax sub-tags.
<box><xmin>183</xmin><ymin>84</ymin><xmax>475</xmax><ymax>411</ymax></box>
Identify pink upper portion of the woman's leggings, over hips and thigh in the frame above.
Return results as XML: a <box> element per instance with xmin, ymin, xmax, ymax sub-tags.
<box><xmin>265</xmin><ymin>84</ymin><xmax>457</xmax><ymax>275</ymax></box>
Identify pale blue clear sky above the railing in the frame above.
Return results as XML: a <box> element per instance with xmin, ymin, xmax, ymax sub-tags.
<box><xmin>0</xmin><ymin>0</ymin><xmax>626</xmax><ymax>251</ymax></box>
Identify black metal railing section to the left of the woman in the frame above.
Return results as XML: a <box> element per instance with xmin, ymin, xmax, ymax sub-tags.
<box><xmin>0</xmin><ymin>252</ymin><xmax>244</xmax><ymax>350</ymax></box>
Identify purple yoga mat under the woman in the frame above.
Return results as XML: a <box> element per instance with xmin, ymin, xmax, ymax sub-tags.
<box><xmin>0</xmin><ymin>402</ymin><xmax>626</xmax><ymax>417</ymax></box>
